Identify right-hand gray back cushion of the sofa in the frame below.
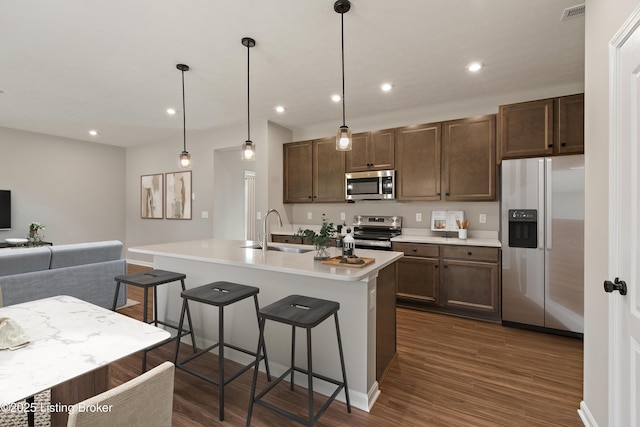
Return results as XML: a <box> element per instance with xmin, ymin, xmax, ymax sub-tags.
<box><xmin>49</xmin><ymin>240</ymin><xmax>122</xmax><ymax>269</ymax></box>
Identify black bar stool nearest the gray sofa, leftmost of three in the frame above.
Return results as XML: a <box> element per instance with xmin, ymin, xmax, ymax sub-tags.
<box><xmin>111</xmin><ymin>270</ymin><xmax>197</xmax><ymax>373</ymax></box>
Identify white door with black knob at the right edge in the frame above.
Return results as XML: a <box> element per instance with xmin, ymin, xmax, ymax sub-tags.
<box><xmin>605</xmin><ymin>7</ymin><xmax>640</xmax><ymax>427</ymax></box>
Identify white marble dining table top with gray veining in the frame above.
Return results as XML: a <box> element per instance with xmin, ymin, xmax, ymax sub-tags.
<box><xmin>0</xmin><ymin>296</ymin><xmax>170</xmax><ymax>405</ymax></box>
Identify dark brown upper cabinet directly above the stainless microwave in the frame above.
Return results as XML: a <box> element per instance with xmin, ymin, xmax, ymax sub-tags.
<box><xmin>346</xmin><ymin>129</ymin><xmax>395</xmax><ymax>172</ymax></box>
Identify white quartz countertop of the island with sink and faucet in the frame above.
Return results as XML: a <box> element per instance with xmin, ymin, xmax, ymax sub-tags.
<box><xmin>129</xmin><ymin>239</ymin><xmax>403</xmax><ymax>281</ymax></box>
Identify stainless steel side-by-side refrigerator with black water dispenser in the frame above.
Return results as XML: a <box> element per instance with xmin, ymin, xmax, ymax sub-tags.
<box><xmin>500</xmin><ymin>155</ymin><xmax>584</xmax><ymax>335</ymax></box>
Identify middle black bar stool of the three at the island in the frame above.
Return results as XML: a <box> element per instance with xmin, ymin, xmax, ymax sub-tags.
<box><xmin>173</xmin><ymin>282</ymin><xmax>271</xmax><ymax>421</ymax></box>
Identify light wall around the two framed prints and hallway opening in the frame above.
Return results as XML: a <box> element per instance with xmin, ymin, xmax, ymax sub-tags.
<box><xmin>125</xmin><ymin>120</ymin><xmax>282</xmax><ymax>262</ymax></box>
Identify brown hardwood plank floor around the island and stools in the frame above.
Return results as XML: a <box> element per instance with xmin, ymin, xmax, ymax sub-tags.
<box><xmin>111</xmin><ymin>270</ymin><xmax>583</xmax><ymax>427</ymax></box>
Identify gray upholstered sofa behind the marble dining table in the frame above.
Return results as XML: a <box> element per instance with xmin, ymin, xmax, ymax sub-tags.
<box><xmin>0</xmin><ymin>240</ymin><xmax>127</xmax><ymax>309</ymax></box>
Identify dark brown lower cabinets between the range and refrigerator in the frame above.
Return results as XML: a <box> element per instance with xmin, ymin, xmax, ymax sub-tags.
<box><xmin>393</xmin><ymin>243</ymin><xmax>501</xmax><ymax>322</ymax></box>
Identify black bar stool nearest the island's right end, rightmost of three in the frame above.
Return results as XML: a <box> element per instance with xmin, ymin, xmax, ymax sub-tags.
<box><xmin>247</xmin><ymin>295</ymin><xmax>351</xmax><ymax>427</ymax></box>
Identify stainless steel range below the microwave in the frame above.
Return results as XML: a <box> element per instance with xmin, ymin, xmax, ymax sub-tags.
<box><xmin>353</xmin><ymin>215</ymin><xmax>402</xmax><ymax>251</ymax></box>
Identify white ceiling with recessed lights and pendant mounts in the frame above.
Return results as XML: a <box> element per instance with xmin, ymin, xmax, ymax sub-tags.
<box><xmin>0</xmin><ymin>0</ymin><xmax>584</xmax><ymax>147</ymax></box>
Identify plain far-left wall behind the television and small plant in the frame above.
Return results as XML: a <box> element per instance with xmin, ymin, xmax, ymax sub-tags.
<box><xmin>0</xmin><ymin>128</ymin><xmax>125</xmax><ymax>245</ymax></box>
